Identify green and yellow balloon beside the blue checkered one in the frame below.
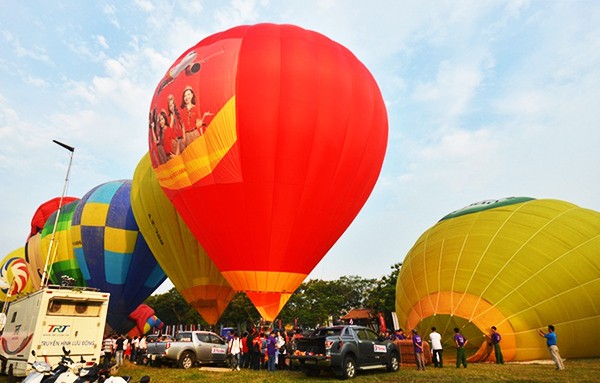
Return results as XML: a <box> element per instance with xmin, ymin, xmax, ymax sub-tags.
<box><xmin>40</xmin><ymin>200</ymin><xmax>85</xmax><ymax>286</ymax></box>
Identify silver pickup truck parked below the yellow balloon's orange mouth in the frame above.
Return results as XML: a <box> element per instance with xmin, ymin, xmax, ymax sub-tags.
<box><xmin>146</xmin><ymin>331</ymin><xmax>227</xmax><ymax>369</ymax></box>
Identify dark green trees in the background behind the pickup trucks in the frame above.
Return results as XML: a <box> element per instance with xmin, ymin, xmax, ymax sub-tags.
<box><xmin>144</xmin><ymin>263</ymin><xmax>401</xmax><ymax>328</ymax></box>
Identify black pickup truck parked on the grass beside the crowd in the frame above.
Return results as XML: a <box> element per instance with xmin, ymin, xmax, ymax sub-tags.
<box><xmin>287</xmin><ymin>326</ymin><xmax>400</xmax><ymax>379</ymax></box>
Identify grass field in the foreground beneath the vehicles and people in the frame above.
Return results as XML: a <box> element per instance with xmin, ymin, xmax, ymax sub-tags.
<box><xmin>0</xmin><ymin>359</ymin><xmax>600</xmax><ymax>383</ymax></box>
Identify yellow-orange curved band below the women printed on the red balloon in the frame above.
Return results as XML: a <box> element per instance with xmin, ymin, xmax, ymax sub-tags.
<box><xmin>155</xmin><ymin>96</ymin><xmax>237</xmax><ymax>190</ymax></box>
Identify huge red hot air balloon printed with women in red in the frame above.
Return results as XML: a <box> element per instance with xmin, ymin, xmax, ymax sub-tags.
<box><xmin>148</xmin><ymin>24</ymin><xmax>388</xmax><ymax>320</ymax></box>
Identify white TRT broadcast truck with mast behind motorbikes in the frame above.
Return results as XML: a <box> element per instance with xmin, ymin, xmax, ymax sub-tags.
<box><xmin>0</xmin><ymin>286</ymin><xmax>110</xmax><ymax>382</ymax></box>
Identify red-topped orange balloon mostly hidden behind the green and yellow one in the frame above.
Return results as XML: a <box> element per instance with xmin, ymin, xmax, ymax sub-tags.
<box><xmin>25</xmin><ymin>197</ymin><xmax>78</xmax><ymax>289</ymax></box>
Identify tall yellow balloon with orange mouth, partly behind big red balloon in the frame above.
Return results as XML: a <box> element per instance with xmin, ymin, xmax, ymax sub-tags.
<box><xmin>131</xmin><ymin>155</ymin><xmax>234</xmax><ymax>325</ymax></box>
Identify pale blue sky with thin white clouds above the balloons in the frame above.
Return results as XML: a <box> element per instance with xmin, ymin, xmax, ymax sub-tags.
<box><xmin>0</xmin><ymin>0</ymin><xmax>600</xmax><ymax>290</ymax></box>
